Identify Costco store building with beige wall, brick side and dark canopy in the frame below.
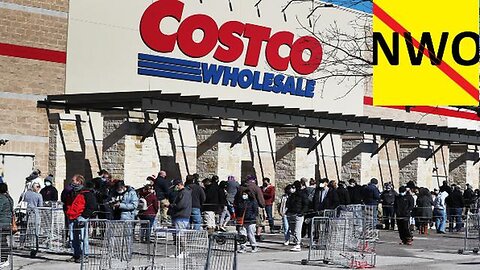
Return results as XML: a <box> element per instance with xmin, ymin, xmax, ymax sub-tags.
<box><xmin>0</xmin><ymin>0</ymin><xmax>480</xmax><ymax>202</ymax></box>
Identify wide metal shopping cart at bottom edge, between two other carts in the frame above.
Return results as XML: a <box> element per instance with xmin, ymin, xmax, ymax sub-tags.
<box><xmin>152</xmin><ymin>228</ymin><xmax>208</xmax><ymax>270</ymax></box>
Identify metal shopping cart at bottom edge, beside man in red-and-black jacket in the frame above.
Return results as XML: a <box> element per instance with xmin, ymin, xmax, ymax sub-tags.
<box><xmin>82</xmin><ymin>220</ymin><xmax>154</xmax><ymax>270</ymax></box>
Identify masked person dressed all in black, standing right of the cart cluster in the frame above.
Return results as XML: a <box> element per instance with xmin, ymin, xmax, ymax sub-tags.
<box><xmin>394</xmin><ymin>186</ymin><xmax>415</xmax><ymax>245</ymax></box>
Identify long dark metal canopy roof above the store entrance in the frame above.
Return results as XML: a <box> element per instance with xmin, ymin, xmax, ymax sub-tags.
<box><xmin>38</xmin><ymin>91</ymin><xmax>480</xmax><ymax>145</ymax></box>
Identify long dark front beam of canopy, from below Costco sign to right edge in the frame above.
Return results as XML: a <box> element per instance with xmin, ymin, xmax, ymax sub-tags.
<box><xmin>142</xmin><ymin>98</ymin><xmax>480</xmax><ymax>145</ymax></box>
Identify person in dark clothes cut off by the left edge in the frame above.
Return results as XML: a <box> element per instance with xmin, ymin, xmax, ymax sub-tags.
<box><xmin>0</xmin><ymin>183</ymin><xmax>13</xmax><ymax>269</ymax></box>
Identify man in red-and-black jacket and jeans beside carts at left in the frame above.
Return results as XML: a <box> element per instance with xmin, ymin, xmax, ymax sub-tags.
<box><xmin>67</xmin><ymin>175</ymin><xmax>97</xmax><ymax>263</ymax></box>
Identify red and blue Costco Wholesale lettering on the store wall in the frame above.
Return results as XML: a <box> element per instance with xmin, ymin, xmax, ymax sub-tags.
<box><xmin>138</xmin><ymin>0</ymin><xmax>323</xmax><ymax>98</ymax></box>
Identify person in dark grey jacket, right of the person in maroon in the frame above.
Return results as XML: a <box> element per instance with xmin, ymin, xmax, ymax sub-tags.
<box><xmin>168</xmin><ymin>179</ymin><xmax>192</xmax><ymax>230</ymax></box>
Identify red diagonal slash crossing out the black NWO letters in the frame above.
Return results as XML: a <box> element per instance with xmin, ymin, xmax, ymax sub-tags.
<box><xmin>373</xmin><ymin>3</ymin><xmax>478</xmax><ymax>102</ymax></box>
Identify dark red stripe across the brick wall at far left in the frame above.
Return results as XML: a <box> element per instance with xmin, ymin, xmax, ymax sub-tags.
<box><xmin>0</xmin><ymin>43</ymin><xmax>67</xmax><ymax>64</ymax></box>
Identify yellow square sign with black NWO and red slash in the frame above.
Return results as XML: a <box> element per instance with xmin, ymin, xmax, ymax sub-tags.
<box><xmin>373</xmin><ymin>0</ymin><xmax>479</xmax><ymax>106</ymax></box>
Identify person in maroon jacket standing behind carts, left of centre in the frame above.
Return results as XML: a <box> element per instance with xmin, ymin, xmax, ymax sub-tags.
<box><xmin>138</xmin><ymin>180</ymin><xmax>160</xmax><ymax>242</ymax></box>
